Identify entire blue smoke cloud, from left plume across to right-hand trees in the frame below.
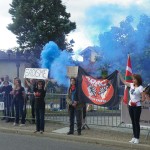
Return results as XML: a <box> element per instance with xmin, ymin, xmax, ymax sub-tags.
<box><xmin>41</xmin><ymin>1</ymin><xmax>150</xmax><ymax>86</ymax></box>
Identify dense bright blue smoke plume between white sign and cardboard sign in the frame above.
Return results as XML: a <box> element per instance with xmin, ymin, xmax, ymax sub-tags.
<box><xmin>41</xmin><ymin>41</ymin><xmax>74</xmax><ymax>87</ymax></box>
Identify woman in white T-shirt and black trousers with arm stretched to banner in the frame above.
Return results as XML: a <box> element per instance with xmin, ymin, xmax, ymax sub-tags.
<box><xmin>119</xmin><ymin>73</ymin><xmax>145</xmax><ymax>144</ymax></box>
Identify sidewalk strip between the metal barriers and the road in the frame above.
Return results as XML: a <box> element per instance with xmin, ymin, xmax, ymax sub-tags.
<box><xmin>0</xmin><ymin>120</ymin><xmax>150</xmax><ymax>150</ymax></box>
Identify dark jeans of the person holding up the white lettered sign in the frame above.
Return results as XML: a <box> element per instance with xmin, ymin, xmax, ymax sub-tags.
<box><xmin>35</xmin><ymin>108</ymin><xmax>45</xmax><ymax>131</ymax></box>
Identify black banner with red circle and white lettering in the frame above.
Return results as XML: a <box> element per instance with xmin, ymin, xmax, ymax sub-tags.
<box><xmin>77</xmin><ymin>67</ymin><xmax>119</xmax><ymax>107</ymax></box>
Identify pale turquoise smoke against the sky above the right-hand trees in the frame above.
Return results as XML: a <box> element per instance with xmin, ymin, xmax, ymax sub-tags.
<box><xmin>84</xmin><ymin>4</ymin><xmax>149</xmax><ymax>45</ymax></box>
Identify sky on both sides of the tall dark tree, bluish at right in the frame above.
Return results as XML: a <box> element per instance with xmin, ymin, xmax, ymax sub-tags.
<box><xmin>0</xmin><ymin>0</ymin><xmax>150</xmax><ymax>51</ymax></box>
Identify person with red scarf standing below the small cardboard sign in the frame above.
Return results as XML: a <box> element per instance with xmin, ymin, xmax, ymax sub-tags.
<box><xmin>67</xmin><ymin>77</ymin><xmax>83</xmax><ymax>135</ymax></box>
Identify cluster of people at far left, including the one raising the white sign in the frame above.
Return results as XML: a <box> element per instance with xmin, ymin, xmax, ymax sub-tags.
<box><xmin>0</xmin><ymin>75</ymin><xmax>48</xmax><ymax>133</ymax></box>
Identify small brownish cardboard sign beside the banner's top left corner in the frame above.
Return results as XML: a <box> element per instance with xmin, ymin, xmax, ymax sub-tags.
<box><xmin>67</xmin><ymin>66</ymin><xmax>78</xmax><ymax>77</ymax></box>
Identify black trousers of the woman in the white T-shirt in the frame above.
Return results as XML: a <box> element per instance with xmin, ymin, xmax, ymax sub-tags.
<box><xmin>129</xmin><ymin>106</ymin><xmax>141</xmax><ymax>139</ymax></box>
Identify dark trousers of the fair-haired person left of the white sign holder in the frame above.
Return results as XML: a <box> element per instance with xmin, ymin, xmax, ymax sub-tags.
<box><xmin>14</xmin><ymin>99</ymin><xmax>25</xmax><ymax>124</ymax></box>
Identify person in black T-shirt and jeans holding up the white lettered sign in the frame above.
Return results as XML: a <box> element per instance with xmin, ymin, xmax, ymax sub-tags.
<box><xmin>33</xmin><ymin>80</ymin><xmax>48</xmax><ymax>134</ymax></box>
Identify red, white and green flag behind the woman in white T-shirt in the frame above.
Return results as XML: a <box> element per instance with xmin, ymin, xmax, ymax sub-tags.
<box><xmin>123</xmin><ymin>55</ymin><xmax>132</xmax><ymax>104</ymax></box>
